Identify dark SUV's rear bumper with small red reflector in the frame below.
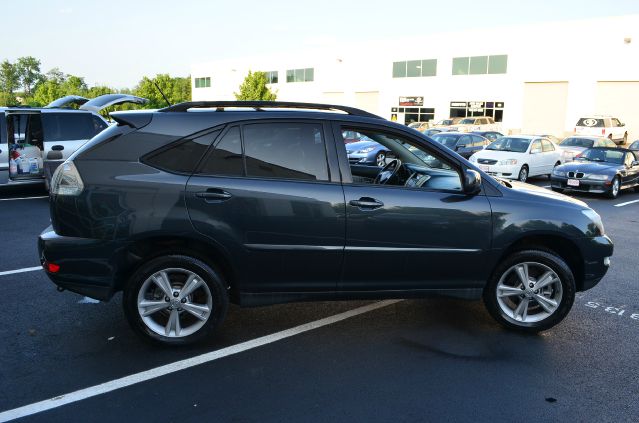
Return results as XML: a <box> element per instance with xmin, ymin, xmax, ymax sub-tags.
<box><xmin>38</xmin><ymin>226</ymin><xmax>125</xmax><ymax>301</ymax></box>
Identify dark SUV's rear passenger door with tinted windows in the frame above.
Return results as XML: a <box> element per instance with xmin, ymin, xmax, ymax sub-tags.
<box><xmin>186</xmin><ymin>119</ymin><xmax>346</xmax><ymax>294</ymax></box>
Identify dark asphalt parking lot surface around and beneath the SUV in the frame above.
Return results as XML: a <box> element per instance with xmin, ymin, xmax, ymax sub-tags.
<box><xmin>0</xmin><ymin>178</ymin><xmax>639</xmax><ymax>422</ymax></box>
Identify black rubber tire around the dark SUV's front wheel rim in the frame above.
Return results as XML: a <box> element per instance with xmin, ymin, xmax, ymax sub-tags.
<box><xmin>483</xmin><ymin>248</ymin><xmax>576</xmax><ymax>333</ymax></box>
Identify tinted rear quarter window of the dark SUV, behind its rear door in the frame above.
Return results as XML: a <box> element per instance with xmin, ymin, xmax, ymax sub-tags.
<box><xmin>142</xmin><ymin>130</ymin><xmax>220</xmax><ymax>173</ymax></box>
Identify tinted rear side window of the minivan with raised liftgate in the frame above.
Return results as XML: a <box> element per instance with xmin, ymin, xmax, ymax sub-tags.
<box><xmin>42</xmin><ymin>113</ymin><xmax>96</xmax><ymax>141</ymax></box>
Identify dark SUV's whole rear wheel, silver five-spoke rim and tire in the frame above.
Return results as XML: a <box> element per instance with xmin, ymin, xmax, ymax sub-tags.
<box><xmin>123</xmin><ymin>255</ymin><xmax>229</xmax><ymax>345</ymax></box>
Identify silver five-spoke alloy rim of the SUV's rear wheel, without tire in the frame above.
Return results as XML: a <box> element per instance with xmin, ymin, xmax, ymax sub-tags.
<box><xmin>137</xmin><ymin>268</ymin><xmax>213</xmax><ymax>338</ymax></box>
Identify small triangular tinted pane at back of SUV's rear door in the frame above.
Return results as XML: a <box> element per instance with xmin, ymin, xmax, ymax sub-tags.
<box><xmin>199</xmin><ymin>126</ymin><xmax>244</xmax><ymax>176</ymax></box>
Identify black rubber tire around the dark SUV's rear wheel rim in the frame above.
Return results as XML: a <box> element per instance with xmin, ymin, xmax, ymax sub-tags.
<box><xmin>123</xmin><ymin>255</ymin><xmax>229</xmax><ymax>346</ymax></box>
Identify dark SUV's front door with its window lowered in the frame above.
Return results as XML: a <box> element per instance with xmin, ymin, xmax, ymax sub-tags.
<box><xmin>334</xmin><ymin>122</ymin><xmax>492</xmax><ymax>293</ymax></box>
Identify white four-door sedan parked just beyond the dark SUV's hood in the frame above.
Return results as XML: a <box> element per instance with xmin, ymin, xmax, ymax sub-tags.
<box><xmin>470</xmin><ymin>135</ymin><xmax>561</xmax><ymax>182</ymax></box>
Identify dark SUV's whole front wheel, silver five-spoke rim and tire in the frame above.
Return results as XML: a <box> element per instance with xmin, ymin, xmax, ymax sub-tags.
<box><xmin>484</xmin><ymin>249</ymin><xmax>575</xmax><ymax>332</ymax></box>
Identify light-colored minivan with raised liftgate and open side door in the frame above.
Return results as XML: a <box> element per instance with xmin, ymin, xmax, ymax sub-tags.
<box><xmin>0</xmin><ymin>94</ymin><xmax>148</xmax><ymax>186</ymax></box>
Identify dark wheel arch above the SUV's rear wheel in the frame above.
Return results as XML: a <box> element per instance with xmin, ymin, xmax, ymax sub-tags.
<box><xmin>115</xmin><ymin>236</ymin><xmax>239</xmax><ymax>302</ymax></box>
